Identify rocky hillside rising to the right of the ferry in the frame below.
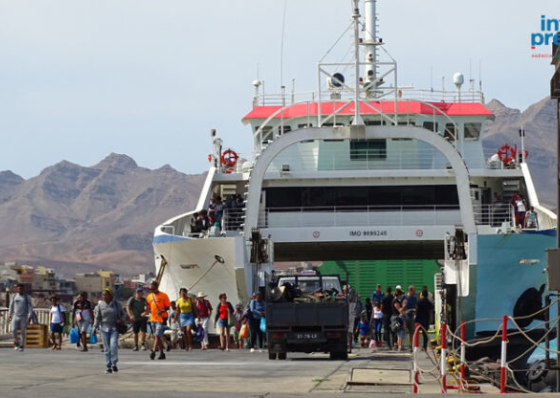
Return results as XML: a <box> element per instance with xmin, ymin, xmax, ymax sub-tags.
<box><xmin>483</xmin><ymin>98</ymin><xmax>557</xmax><ymax>208</ymax></box>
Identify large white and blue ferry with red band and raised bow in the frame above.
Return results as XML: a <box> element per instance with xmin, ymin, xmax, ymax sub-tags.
<box><xmin>153</xmin><ymin>0</ymin><xmax>557</xmax><ymax>338</ymax></box>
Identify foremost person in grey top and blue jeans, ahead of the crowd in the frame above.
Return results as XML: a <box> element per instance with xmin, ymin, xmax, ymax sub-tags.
<box><xmin>91</xmin><ymin>289</ymin><xmax>126</xmax><ymax>374</ymax></box>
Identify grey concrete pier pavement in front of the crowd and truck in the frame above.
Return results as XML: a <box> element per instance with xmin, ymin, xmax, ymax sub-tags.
<box><xmin>0</xmin><ymin>347</ymin><xmax>552</xmax><ymax>398</ymax></box>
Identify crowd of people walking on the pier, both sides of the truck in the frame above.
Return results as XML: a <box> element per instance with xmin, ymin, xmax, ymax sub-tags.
<box><xmin>9</xmin><ymin>281</ymin><xmax>434</xmax><ymax>374</ymax></box>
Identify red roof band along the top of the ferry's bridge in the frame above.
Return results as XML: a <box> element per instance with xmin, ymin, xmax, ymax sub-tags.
<box><xmin>243</xmin><ymin>101</ymin><xmax>493</xmax><ymax>120</ymax></box>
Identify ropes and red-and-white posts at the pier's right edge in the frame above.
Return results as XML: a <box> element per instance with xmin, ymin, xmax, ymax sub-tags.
<box><xmin>413</xmin><ymin>298</ymin><xmax>560</xmax><ymax>393</ymax></box>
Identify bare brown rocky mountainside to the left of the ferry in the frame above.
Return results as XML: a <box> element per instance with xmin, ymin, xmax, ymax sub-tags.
<box><xmin>0</xmin><ymin>154</ymin><xmax>204</xmax><ymax>275</ymax></box>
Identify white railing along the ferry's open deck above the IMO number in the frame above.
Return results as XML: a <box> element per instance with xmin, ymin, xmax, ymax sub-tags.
<box><xmin>254</xmin><ymin>205</ymin><xmax>513</xmax><ymax>228</ymax></box>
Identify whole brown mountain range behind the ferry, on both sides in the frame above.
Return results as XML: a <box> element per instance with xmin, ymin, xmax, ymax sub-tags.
<box><xmin>0</xmin><ymin>98</ymin><xmax>557</xmax><ymax>276</ymax></box>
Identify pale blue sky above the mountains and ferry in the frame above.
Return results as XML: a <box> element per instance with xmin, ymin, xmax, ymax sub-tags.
<box><xmin>0</xmin><ymin>0</ymin><xmax>560</xmax><ymax>178</ymax></box>
